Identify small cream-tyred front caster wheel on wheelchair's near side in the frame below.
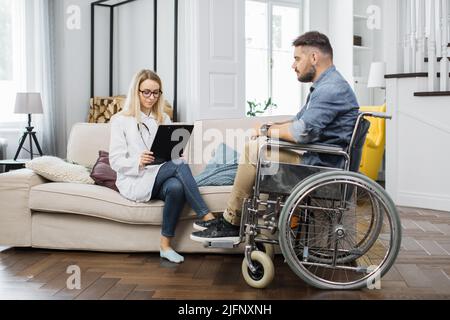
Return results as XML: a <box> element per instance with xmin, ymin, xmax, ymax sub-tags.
<box><xmin>242</xmin><ymin>251</ymin><xmax>275</xmax><ymax>289</ymax></box>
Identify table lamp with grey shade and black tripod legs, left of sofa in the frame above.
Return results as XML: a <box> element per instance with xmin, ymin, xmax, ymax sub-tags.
<box><xmin>14</xmin><ymin>92</ymin><xmax>43</xmax><ymax>160</ymax></box>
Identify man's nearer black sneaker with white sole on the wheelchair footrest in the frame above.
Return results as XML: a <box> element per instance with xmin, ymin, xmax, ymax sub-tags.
<box><xmin>191</xmin><ymin>217</ymin><xmax>240</xmax><ymax>243</ymax></box>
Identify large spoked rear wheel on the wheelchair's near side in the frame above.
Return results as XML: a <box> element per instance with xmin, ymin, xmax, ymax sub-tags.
<box><xmin>278</xmin><ymin>171</ymin><xmax>401</xmax><ymax>289</ymax></box>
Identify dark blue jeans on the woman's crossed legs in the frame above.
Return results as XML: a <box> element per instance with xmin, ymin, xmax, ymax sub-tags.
<box><xmin>152</xmin><ymin>161</ymin><xmax>209</xmax><ymax>237</ymax></box>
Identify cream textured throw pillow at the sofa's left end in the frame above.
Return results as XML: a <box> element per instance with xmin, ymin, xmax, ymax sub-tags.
<box><xmin>25</xmin><ymin>156</ymin><xmax>95</xmax><ymax>184</ymax></box>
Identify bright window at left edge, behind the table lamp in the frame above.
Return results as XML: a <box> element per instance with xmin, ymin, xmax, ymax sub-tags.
<box><xmin>0</xmin><ymin>0</ymin><xmax>25</xmax><ymax>123</ymax></box>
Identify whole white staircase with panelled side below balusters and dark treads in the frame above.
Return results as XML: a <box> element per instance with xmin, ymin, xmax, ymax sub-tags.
<box><xmin>385</xmin><ymin>0</ymin><xmax>450</xmax><ymax>215</ymax></box>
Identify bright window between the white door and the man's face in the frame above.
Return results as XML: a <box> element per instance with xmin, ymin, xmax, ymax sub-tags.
<box><xmin>245</xmin><ymin>0</ymin><xmax>301</xmax><ymax>115</ymax></box>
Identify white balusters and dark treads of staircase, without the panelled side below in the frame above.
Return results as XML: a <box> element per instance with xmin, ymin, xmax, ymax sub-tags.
<box><xmin>386</xmin><ymin>0</ymin><xmax>450</xmax><ymax>97</ymax></box>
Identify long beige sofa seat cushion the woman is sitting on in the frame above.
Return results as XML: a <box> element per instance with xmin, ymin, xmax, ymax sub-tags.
<box><xmin>29</xmin><ymin>183</ymin><xmax>231</xmax><ymax>225</ymax></box>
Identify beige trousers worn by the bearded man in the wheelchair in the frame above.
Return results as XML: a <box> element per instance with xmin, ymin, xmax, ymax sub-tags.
<box><xmin>223</xmin><ymin>137</ymin><xmax>301</xmax><ymax>225</ymax></box>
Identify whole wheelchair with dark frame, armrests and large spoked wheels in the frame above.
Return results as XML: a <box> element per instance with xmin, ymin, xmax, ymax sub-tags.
<box><xmin>205</xmin><ymin>112</ymin><xmax>401</xmax><ymax>290</ymax></box>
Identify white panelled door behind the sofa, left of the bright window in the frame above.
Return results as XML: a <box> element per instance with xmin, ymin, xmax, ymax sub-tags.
<box><xmin>179</xmin><ymin>0</ymin><xmax>245</xmax><ymax>122</ymax></box>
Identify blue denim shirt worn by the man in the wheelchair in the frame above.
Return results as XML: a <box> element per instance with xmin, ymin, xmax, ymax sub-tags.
<box><xmin>290</xmin><ymin>66</ymin><xmax>359</xmax><ymax>168</ymax></box>
